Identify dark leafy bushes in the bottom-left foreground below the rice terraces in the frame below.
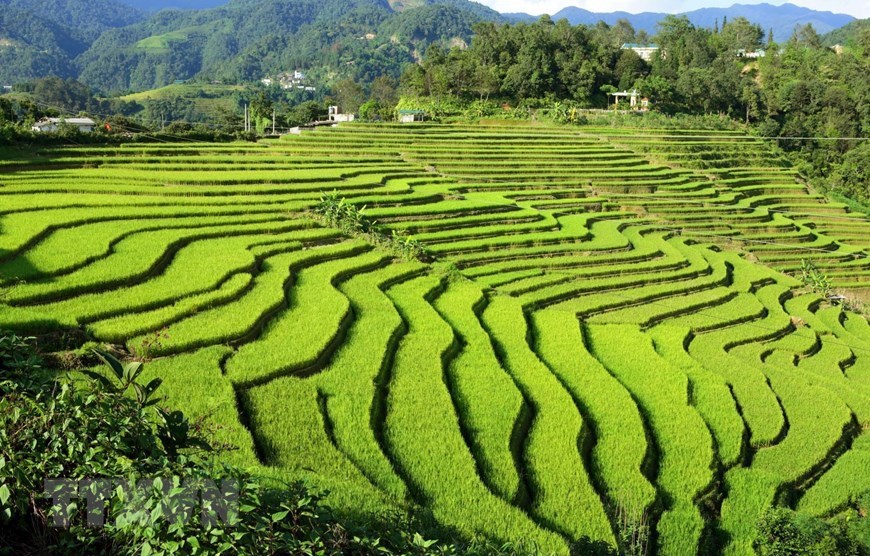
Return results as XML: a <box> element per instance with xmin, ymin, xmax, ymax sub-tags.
<box><xmin>0</xmin><ymin>334</ymin><xmax>507</xmax><ymax>554</ymax></box>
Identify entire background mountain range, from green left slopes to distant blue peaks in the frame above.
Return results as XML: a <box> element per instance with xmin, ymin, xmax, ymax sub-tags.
<box><xmin>0</xmin><ymin>0</ymin><xmax>854</xmax><ymax>93</ymax></box>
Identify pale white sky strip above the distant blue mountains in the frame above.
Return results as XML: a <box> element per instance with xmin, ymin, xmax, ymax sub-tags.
<box><xmin>477</xmin><ymin>0</ymin><xmax>870</xmax><ymax>18</ymax></box>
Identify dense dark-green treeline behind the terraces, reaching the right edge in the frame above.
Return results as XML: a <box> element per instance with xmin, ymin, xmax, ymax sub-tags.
<box><xmin>401</xmin><ymin>16</ymin><xmax>870</xmax><ymax>202</ymax></box>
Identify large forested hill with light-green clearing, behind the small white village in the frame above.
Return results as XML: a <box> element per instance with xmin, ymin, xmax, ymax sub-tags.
<box><xmin>78</xmin><ymin>0</ymin><xmax>499</xmax><ymax>91</ymax></box>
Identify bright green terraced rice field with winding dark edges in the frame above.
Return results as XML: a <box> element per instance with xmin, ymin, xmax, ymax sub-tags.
<box><xmin>0</xmin><ymin>124</ymin><xmax>870</xmax><ymax>555</ymax></box>
